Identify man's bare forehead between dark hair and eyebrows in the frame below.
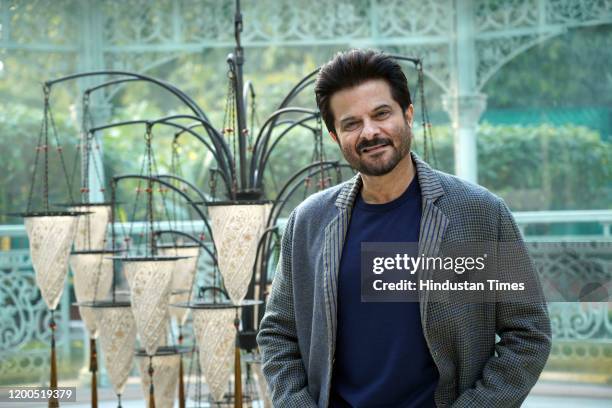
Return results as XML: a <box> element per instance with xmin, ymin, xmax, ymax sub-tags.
<box><xmin>329</xmin><ymin>79</ymin><xmax>399</xmax><ymax>122</ymax></box>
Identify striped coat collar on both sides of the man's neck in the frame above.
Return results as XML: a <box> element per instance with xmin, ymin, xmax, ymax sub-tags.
<box><xmin>335</xmin><ymin>152</ymin><xmax>444</xmax><ymax>210</ymax></box>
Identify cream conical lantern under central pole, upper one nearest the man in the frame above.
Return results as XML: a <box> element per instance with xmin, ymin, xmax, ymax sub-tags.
<box><xmin>208</xmin><ymin>203</ymin><xmax>271</xmax><ymax>305</ymax></box>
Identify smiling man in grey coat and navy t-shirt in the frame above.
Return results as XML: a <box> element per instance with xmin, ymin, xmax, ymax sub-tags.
<box><xmin>257</xmin><ymin>50</ymin><xmax>550</xmax><ymax>408</ymax></box>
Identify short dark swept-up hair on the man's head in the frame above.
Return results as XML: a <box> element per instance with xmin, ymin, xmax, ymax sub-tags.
<box><xmin>315</xmin><ymin>49</ymin><xmax>412</xmax><ymax>133</ymax></box>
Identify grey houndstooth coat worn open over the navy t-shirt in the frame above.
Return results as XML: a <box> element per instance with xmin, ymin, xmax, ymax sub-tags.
<box><xmin>257</xmin><ymin>154</ymin><xmax>550</xmax><ymax>408</ymax></box>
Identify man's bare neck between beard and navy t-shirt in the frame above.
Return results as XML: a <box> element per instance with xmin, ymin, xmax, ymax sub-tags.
<box><xmin>361</xmin><ymin>154</ymin><xmax>415</xmax><ymax>204</ymax></box>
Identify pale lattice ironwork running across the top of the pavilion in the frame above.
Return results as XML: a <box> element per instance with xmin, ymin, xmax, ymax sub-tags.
<box><xmin>0</xmin><ymin>0</ymin><xmax>612</xmax><ymax>90</ymax></box>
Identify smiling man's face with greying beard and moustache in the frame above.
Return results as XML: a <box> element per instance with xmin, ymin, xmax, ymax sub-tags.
<box><xmin>330</xmin><ymin>79</ymin><xmax>413</xmax><ymax>176</ymax></box>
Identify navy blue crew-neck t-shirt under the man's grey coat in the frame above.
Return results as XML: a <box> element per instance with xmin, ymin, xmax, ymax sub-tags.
<box><xmin>330</xmin><ymin>176</ymin><xmax>438</xmax><ymax>408</ymax></box>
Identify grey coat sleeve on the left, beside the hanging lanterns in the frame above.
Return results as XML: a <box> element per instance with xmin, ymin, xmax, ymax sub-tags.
<box><xmin>257</xmin><ymin>211</ymin><xmax>317</xmax><ymax>408</ymax></box>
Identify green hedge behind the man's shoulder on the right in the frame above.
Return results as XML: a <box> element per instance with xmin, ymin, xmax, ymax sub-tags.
<box><xmin>417</xmin><ymin>123</ymin><xmax>612</xmax><ymax>211</ymax></box>
